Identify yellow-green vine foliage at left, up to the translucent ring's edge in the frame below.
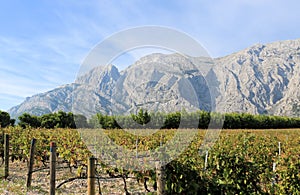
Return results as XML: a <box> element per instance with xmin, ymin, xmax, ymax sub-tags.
<box><xmin>0</xmin><ymin>126</ymin><xmax>91</xmax><ymax>167</ymax></box>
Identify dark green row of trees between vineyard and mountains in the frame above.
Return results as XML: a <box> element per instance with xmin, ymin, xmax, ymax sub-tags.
<box><xmin>0</xmin><ymin>109</ymin><xmax>300</xmax><ymax>129</ymax></box>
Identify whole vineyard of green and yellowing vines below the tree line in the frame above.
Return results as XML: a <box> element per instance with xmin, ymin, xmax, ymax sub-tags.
<box><xmin>0</xmin><ymin>127</ymin><xmax>300</xmax><ymax>194</ymax></box>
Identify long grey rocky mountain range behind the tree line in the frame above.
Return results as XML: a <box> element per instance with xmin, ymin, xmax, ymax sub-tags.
<box><xmin>9</xmin><ymin>39</ymin><xmax>300</xmax><ymax>117</ymax></box>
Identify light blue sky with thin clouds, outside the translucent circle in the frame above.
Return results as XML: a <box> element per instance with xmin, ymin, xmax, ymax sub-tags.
<box><xmin>0</xmin><ymin>0</ymin><xmax>300</xmax><ymax>110</ymax></box>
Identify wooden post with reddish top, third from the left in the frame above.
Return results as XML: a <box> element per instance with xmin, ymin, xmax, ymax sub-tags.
<box><xmin>50</xmin><ymin>142</ymin><xmax>56</xmax><ymax>195</ymax></box>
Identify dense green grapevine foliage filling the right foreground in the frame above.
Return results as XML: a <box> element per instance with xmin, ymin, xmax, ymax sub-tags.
<box><xmin>159</xmin><ymin>130</ymin><xmax>300</xmax><ymax>194</ymax></box>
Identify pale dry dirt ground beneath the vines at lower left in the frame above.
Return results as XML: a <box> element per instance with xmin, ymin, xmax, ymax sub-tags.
<box><xmin>0</xmin><ymin>162</ymin><xmax>155</xmax><ymax>195</ymax></box>
